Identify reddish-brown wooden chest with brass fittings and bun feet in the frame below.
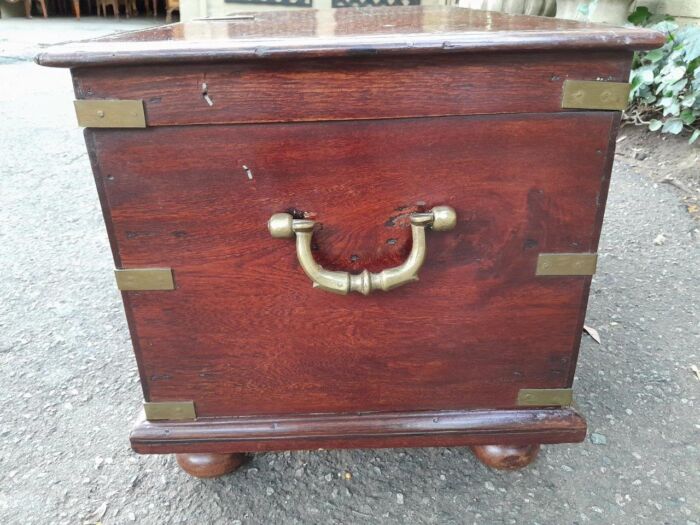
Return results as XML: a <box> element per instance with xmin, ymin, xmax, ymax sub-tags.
<box><xmin>37</xmin><ymin>7</ymin><xmax>662</xmax><ymax>476</ymax></box>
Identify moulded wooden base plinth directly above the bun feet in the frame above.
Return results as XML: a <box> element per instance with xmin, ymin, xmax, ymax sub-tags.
<box><xmin>130</xmin><ymin>408</ymin><xmax>586</xmax><ymax>454</ymax></box>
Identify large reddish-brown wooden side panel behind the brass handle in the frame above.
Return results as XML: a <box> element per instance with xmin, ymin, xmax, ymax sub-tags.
<box><xmin>89</xmin><ymin>112</ymin><xmax>617</xmax><ymax>417</ymax></box>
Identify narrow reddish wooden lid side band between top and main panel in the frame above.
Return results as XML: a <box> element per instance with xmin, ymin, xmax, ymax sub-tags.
<box><xmin>73</xmin><ymin>51</ymin><xmax>632</xmax><ymax>126</ymax></box>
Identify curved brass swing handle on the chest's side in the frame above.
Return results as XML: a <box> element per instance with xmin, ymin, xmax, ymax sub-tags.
<box><xmin>267</xmin><ymin>206</ymin><xmax>457</xmax><ymax>295</ymax></box>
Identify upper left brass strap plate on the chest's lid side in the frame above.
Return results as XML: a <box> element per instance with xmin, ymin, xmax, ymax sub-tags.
<box><xmin>73</xmin><ymin>100</ymin><xmax>146</xmax><ymax>128</ymax></box>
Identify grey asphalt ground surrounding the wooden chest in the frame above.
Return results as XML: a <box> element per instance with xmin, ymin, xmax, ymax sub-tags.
<box><xmin>0</xmin><ymin>16</ymin><xmax>700</xmax><ymax>525</ymax></box>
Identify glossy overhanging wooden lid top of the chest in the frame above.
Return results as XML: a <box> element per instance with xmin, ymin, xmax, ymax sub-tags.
<box><xmin>36</xmin><ymin>6</ymin><xmax>665</xmax><ymax>67</ymax></box>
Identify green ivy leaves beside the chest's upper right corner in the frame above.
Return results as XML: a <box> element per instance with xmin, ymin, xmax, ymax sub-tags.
<box><xmin>626</xmin><ymin>8</ymin><xmax>700</xmax><ymax>144</ymax></box>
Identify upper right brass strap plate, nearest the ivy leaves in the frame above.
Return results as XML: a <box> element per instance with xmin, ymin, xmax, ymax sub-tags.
<box><xmin>561</xmin><ymin>80</ymin><xmax>631</xmax><ymax>111</ymax></box>
